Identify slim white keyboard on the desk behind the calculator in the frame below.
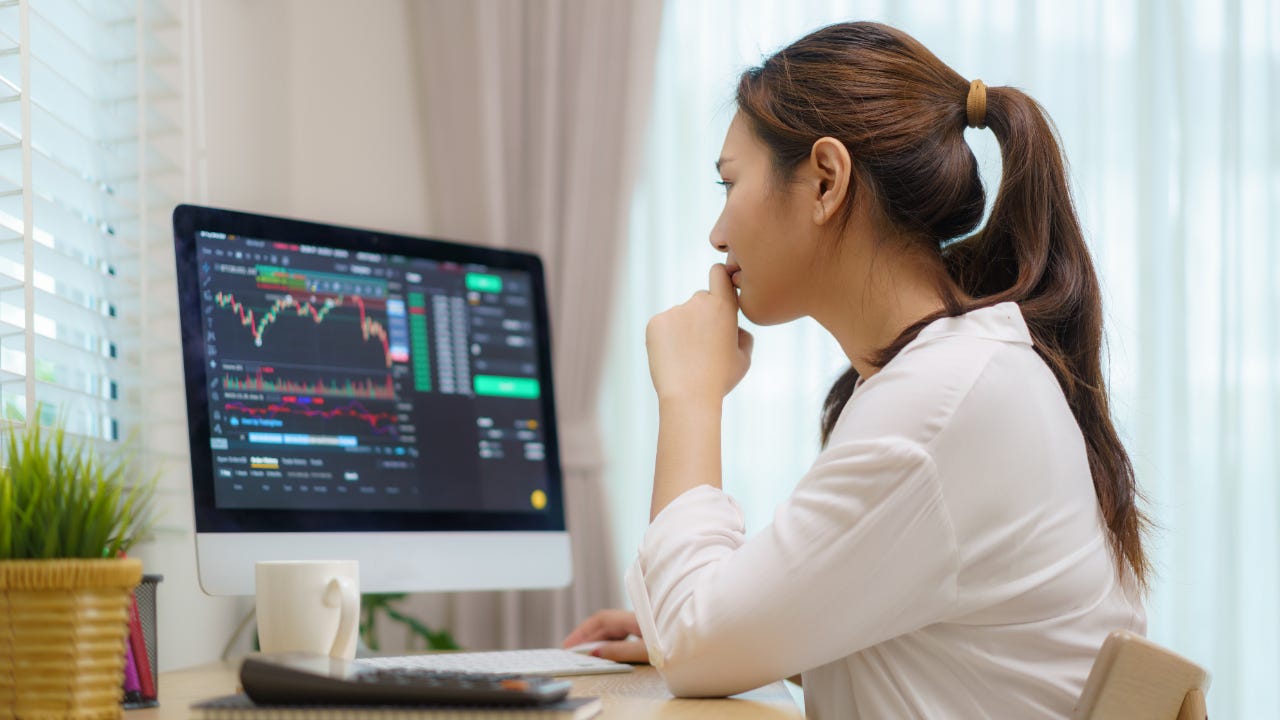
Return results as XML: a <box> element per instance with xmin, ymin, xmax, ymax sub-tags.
<box><xmin>356</xmin><ymin>648</ymin><xmax>631</xmax><ymax>675</ymax></box>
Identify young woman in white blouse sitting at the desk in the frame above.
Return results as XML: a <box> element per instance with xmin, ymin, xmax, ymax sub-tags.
<box><xmin>566</xmin><ymin>23</ymin><xmax>1148</xmax><ymax>717</ymax></box>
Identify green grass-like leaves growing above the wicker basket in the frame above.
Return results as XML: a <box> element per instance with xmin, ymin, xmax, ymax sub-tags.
<box><xmin>0</xmin><ymin>413</ymin><xmax>155</xmax><ymax>560</ymax></box>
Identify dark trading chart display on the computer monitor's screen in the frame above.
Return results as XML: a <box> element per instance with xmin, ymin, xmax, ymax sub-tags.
<box><xmin>196</xmin><ymin>231</ymin><xmax>548</xmax><ymax>512</ymax></box>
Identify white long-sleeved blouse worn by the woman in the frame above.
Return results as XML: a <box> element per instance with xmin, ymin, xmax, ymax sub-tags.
<box><xmin>627</xmin><ymin>302</ymin><xmax>1146</xmax><ymax>719</ymax></box>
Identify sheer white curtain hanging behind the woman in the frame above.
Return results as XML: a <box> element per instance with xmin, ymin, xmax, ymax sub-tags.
<box><xmin>602</xmin><ymin>0</ymin><xmax>1280</xmax><ymax>717</ymax></box>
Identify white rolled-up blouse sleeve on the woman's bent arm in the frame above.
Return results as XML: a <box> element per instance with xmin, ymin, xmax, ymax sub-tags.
<box><xmin>626</xmin><ymin>438</ymin><xmax>959</xmax><ymax>697</ymax></box>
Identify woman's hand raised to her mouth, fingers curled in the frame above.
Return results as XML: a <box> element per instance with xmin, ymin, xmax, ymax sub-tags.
<box><xmin>645</xmin><ymin>264</ymin><xmax>754</xmax><ymax>404</ymax></box>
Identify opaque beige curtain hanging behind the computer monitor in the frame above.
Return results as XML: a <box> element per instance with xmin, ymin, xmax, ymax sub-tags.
<box><xmin>407</xmin><ymin>0</ymin><xmax>660</xmax><ymax>648</ymax></box>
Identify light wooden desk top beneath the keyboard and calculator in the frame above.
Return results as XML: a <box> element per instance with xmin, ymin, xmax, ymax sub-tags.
<box><xmin>124</xmin><ymin>662</ymin><xmax>801</xmax><ymax>720</ymax></box>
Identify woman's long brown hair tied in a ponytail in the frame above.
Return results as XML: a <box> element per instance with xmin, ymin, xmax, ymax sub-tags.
<box><xmin>737</xmin><ymin>22</ymin><xmax>1149</xmax><ymax>587</ymax></box>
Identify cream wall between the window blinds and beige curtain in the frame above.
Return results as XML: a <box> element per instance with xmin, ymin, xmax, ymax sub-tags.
<box><xmin>137</xmin><ymin>0</ymin><xmax>426</xmax><ymax>670</ymax></box>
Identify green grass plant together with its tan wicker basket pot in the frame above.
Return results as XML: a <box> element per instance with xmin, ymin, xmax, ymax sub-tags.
<box><xmin>0</xmin><ymin>413</ymin><xmax>155</xmax><ymax>720</ymax></box>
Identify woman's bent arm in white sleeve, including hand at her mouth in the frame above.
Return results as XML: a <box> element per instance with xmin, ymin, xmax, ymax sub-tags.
<box><xmin>627</xmin><ymin>265</ymin><xmax>957</xmax><ymax>696</ymax></box>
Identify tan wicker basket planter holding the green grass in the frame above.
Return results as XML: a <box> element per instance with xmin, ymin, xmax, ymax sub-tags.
<box><xmin>0</xmin><ymin>559</ymin><xmax>142</xmax><ymax>720</ymax></box>
